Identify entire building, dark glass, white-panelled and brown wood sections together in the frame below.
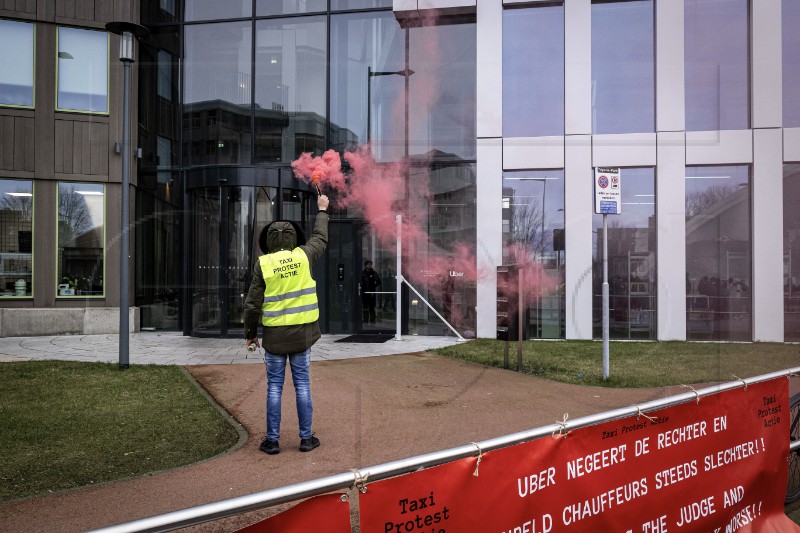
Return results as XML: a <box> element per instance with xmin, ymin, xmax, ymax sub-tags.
<box><xmin>0</xmin><ymin>0</ymin><xmax>800</xmax><ymax>342</ymax></box>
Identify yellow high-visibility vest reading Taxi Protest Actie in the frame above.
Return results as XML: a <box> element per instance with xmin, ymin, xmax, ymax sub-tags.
<box><xmin>258</xmin><ymin>248</ymin><xmax>319</xmax><ymax>326</ymax></box>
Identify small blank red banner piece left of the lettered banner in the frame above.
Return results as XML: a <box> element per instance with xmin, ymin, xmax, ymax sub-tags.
<box><xmin>237</xmin><ymin>494</ymin><xmax>350</xmax><ymax>533</ymax></box>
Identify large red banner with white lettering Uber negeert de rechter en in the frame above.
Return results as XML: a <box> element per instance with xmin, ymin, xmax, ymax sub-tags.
<box><xmin>360</xmin><ymin>378</ymin><xmax>800</xmax><ymax>533</ymax></box>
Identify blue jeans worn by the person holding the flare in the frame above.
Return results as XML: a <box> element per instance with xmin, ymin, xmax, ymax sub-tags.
<box><xmin>264</xmin><ymin>348</ymin><xmax>314</xmax><ymax>440</ymax></box>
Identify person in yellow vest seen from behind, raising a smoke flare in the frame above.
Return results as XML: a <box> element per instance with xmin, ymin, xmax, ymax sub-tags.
<box><xmin>244</xmin><ymin>194</ymin><xmax>329</xmax><ymax>455</ymax></box>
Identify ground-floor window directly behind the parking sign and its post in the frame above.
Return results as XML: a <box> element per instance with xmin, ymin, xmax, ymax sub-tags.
<box><xmin>592</xmin><ymin>168</ymin><xmax>656</xmax><ymax>339</ymax></box>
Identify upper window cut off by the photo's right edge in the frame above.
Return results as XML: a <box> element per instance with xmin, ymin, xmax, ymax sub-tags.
<box><xmin>781</xmin><ymin>0</ymin><xmax>800</xmax><ymax>128</ymax></box>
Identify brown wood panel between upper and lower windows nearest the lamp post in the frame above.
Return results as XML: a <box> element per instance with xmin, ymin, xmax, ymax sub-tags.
<box><xmin>54</xmin><ymin>119</ymin><xmax>109</xmax><ymax>176</ymax></box>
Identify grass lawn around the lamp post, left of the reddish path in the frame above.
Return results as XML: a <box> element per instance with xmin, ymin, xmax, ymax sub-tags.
<box><xmin>0</xmin><ymin>361</ymin><xmax>239</xmax><ymax>501</ymax></box>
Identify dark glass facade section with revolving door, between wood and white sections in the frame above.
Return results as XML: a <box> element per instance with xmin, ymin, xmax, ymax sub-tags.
<box><xmin>136</xmin><ymin>1</ymin><xmax>476</xmax><ymax>336</ymax></box>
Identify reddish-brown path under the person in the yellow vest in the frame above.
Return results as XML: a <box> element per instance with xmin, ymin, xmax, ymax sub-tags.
<box><xmin>0</xmin><ymin>354</ymin><xmax>685</xmax><ymax>532</ymax></box>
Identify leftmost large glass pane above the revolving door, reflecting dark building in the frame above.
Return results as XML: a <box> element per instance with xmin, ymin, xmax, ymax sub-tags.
<box><xmin>183</xmin><ymin>22</ymin><xmax>253</xmax><ymax>165</ymax></box>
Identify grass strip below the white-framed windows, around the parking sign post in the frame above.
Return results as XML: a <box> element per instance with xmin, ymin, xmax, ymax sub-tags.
<box><xmin>432</xmin><ymin>339</ymin><xmax>800</xmax><ymax>387</ymax></box>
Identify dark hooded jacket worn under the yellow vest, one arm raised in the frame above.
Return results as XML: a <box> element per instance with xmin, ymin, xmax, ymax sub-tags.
<box><xmin>244</xmin><ymin>211</ymin><xmax>328</xmax><ymax>355</ymax></box>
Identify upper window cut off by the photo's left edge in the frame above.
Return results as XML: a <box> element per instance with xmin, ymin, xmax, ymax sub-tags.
<box><xmin>0</xmin><ymin>20</ymin><xmax>34</xmax><ymax>107</ymax></box>
